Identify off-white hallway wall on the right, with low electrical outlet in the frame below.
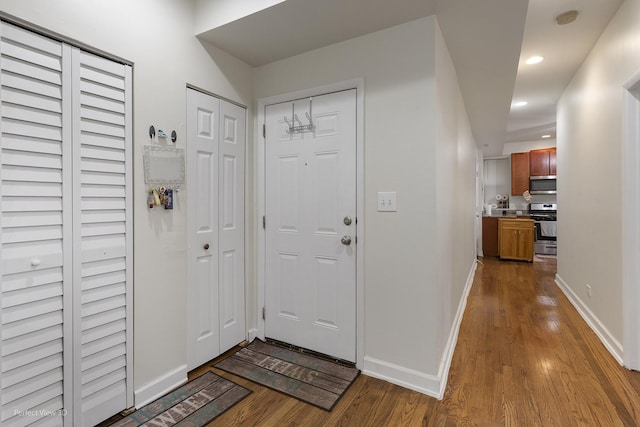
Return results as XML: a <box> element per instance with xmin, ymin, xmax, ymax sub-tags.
<box><xmin>557</xmin><ymin>0</ymin><xmax>640</xmax><ymax>362</ymax></box>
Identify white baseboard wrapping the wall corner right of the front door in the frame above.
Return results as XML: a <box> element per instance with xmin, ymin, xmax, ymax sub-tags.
<box><xmin>362</xmin><ymin>260</ymin><xmax>478</xmax><ymax>399</ymax></box>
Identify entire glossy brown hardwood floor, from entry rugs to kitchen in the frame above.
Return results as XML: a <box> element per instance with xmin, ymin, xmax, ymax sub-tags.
<box><xmin>172</xmin><ymin>259</ymin><xmax>640</xmax><ymax>427</ymax></box>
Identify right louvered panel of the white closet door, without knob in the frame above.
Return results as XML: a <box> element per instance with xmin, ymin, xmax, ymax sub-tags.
<box><xmin>71</xmin><ymin>48</ymin><xmax>133</xmax><ymax>426</ymax></box>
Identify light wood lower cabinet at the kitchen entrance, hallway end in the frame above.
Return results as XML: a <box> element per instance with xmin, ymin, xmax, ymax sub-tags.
<box><xmin>498</xmin><ymin>218</ymin><xmax>534</xmax><ymax>262</ymax></box>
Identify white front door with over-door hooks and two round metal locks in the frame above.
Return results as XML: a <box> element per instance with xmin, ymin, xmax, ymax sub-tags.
<box><xmin>265</xmin><ymin>89</ymin><xmax>357</xmax><ymax>362</ymax></box>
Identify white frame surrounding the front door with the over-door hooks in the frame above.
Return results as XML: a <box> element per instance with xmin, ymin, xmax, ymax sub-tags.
<box><xmin>256</xmin><ymin>78</ymin><xmax>365</xmax><ymax>368</ymax></box>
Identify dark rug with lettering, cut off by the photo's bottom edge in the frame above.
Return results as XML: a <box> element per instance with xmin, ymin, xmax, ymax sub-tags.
<box><xmin>110</xmin><ymin>372</ymin><xmax>251</xmax><ymax>427</ymax></box>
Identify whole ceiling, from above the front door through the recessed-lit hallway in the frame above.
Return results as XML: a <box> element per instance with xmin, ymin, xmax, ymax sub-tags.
<box><xmin>196</xmin><ymin>0</ymin><xmax>622</xmax><ymax>157</ymax></box>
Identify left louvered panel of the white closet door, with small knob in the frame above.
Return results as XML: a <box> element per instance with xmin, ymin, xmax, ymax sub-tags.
<box><xmin>0</xmin><ymin>23</ymin><xmax>72</xmax><ymax>426</ymax></box>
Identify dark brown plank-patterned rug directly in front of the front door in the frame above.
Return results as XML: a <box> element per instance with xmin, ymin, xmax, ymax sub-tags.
<box><xmin>215</xmin><ymin>340</ymin><xmax>360</xmax><ymax>411</ymax></box>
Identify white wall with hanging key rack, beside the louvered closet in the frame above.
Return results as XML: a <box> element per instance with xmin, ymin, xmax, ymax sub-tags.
<box><xmin>0</xmin><ymin>0</ymin><xmax>253</xmax><ymax>403</ymax></box>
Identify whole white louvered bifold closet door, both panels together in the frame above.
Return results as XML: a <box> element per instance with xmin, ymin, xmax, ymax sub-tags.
<box><xmin>0</xmin><ymin>22</ymin><xmax>133</xmax><ymax>426</ymax></box>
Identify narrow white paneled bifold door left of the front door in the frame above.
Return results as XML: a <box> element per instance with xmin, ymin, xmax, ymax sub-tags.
<box><xmin>187</xmin><ymin>89</ymin><xmax>245</xmax><ymax>369</ymax></box>
